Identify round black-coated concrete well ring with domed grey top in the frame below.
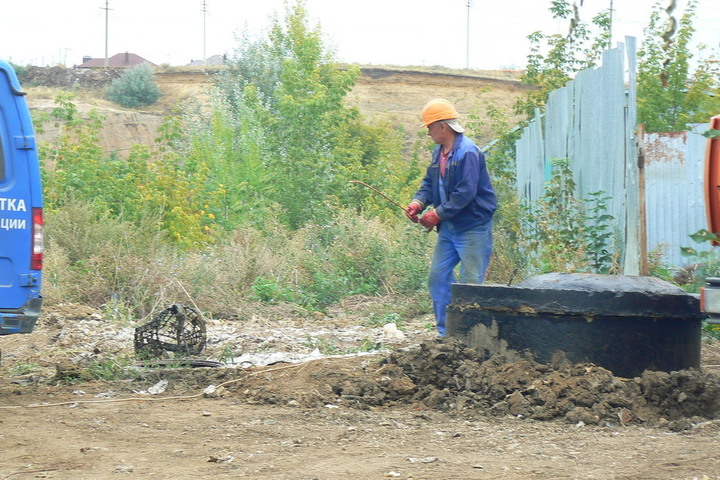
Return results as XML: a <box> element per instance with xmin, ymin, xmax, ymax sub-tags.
<box><xmin>446</xmin><ymin>274</ymin><xmax>705</xmax><ymax>377</ymax></box>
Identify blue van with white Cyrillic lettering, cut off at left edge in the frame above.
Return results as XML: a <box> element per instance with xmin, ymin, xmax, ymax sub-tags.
<box><xmin>0</xmin><ymin>60</ymin><xmax>43</xmax><ymax>335</ymax></box>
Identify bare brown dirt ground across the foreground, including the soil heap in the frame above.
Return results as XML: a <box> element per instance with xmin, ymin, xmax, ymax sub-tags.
<box><xmin>0</xmin><ymin>299</ymin><xmax>720</xmax><ymax>480</ymax></box>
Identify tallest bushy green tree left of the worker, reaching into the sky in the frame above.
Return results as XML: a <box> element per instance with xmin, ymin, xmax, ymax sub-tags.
<box><xmin>208</xmin><ymin>2</ymin><xmax>416</xmax><ymax>228</ymax></box>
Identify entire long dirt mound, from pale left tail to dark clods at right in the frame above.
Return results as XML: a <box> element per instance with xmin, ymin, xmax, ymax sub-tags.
<box><xmin>217</xmin><ymin>339</ymin><xmax>720</xmax><ymax>431</ymax></box>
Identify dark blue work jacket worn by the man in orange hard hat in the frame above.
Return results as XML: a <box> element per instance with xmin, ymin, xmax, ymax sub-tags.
<box><xmin>415</xmin><ymin>133</ymin><xmax>497</xmax><ymax>232</ymax></box>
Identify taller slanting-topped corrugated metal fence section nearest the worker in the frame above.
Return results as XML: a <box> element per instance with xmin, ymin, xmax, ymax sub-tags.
<box><xmin>516</xmin><ymin>37</ymin><xmax>639</xmax><ymax>274</ymax></box>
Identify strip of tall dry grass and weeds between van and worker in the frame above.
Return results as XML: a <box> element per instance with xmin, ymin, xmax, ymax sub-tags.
<box><xmin>43</xmin><ymin>203</ymin><xmax>433</xmax><ymax>318</ymax></box>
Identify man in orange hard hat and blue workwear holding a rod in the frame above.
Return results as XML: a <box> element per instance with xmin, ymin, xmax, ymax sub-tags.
<box><xmin>406</xmin><ymin>99</ymin><xmax>497</xmax><ymax>336</ymax></box>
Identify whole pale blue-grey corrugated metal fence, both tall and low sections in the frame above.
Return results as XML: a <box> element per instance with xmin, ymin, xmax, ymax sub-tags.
<box><xmin>516</xmin><ymin>37</ymin><xmax>711</xmax><ymax>275</ymax></box>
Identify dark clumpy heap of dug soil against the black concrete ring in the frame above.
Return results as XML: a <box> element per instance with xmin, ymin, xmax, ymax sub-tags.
<box><xmin>387</xmin><ymin>341</ymin><xmax>720</xmax><ymax>429</ymax></box>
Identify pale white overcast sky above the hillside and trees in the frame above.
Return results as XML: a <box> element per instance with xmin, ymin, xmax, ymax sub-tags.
<box><xmin>0</xmin><ymin>0</ymin><xmax>720</xmax><ymax>69</ymax></box>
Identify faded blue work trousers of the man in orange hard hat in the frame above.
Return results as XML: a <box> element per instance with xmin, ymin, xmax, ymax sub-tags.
<box><xmin>428</xmin><ymin>221</ymin><xmax>492</xmax><ymax>336</ymax></box>
